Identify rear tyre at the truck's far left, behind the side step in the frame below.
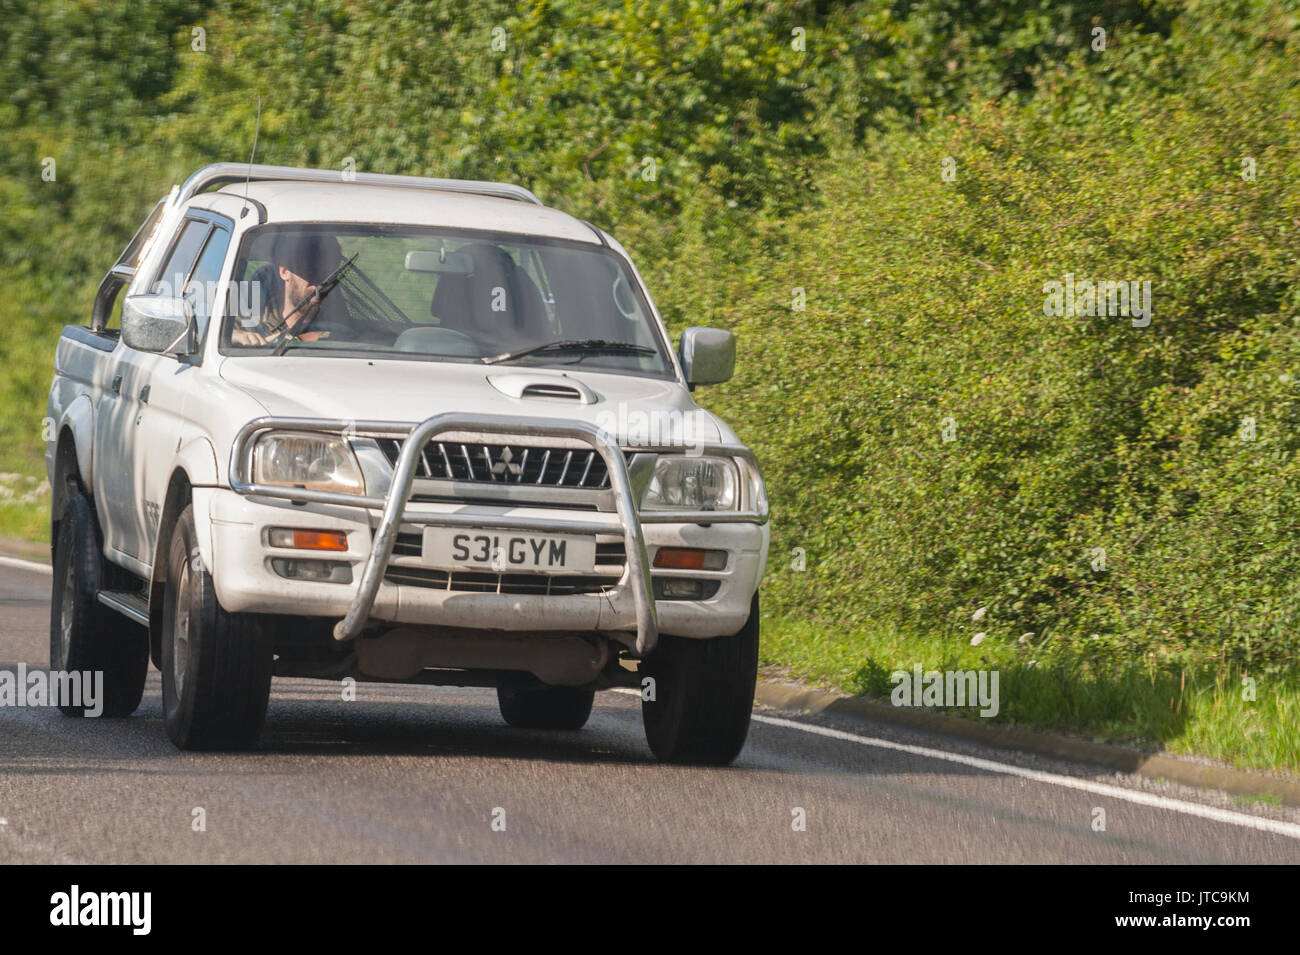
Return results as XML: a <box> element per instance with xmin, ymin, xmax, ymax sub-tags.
<box><xmin>49</xmin><ymin>494</ymin><xmax>150</xmax><ymax>716</ymax></box>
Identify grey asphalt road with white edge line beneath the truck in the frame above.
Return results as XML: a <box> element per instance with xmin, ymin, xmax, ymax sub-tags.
<box><xmin>0</xmin><ymin>565</ymin><xmax>1300</xmax><ymax>864</ymax></box>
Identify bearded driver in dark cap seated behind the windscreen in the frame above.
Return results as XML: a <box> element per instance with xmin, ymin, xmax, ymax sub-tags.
<box><xmin>230</xmin><ymin>233</ymin><xmax>343</xmax><ymax>346</ymax></box>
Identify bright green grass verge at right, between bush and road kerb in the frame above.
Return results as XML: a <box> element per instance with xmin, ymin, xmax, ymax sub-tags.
<box><xmin>759</xmin><ymin>617</ymin><xmax>1300</xmax><ymax>776</ymax></box>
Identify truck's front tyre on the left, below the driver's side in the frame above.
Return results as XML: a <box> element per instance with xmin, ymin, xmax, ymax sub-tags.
<box><xmin>163</xmin><ymin>507</ymin><xmax>273</xmax><ymax>750</ymax></box>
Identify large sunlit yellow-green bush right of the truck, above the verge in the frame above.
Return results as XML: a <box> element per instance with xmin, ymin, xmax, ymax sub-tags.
<box><xmin>719</xmin><ymin>5</ymin><xmax>1300</xmax><ymax>665</ymax></box>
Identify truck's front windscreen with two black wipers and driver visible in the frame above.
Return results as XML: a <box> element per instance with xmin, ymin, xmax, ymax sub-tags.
<box><xmin>221</xmin><ymin>225</ymin><xmax>672</xmax><ymax>376</ymax></box>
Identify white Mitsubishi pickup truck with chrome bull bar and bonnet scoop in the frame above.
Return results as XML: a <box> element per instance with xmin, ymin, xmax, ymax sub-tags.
<box><xmin>46</xmin><ymin>164</ymin><xmax>768</xmax><ymax>764</ymax></box>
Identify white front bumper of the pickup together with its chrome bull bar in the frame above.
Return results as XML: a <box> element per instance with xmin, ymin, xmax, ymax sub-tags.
<box><xmin>223</xmin><ymin>414</ymin><xmax>768</xmax><ymax>655</ymax></box>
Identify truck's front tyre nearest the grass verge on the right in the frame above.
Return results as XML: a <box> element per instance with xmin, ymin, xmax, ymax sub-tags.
<box><xmin>641</xmin><ymin>594</ymin><xmax>758</xmax><ymax>765</ymax></box>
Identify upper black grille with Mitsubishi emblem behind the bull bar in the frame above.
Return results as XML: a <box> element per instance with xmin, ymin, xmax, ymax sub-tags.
<box><xmin>377</xmin><ymin>438</ymin><xmax>624</xmax><ymax>491</ymax></box>
